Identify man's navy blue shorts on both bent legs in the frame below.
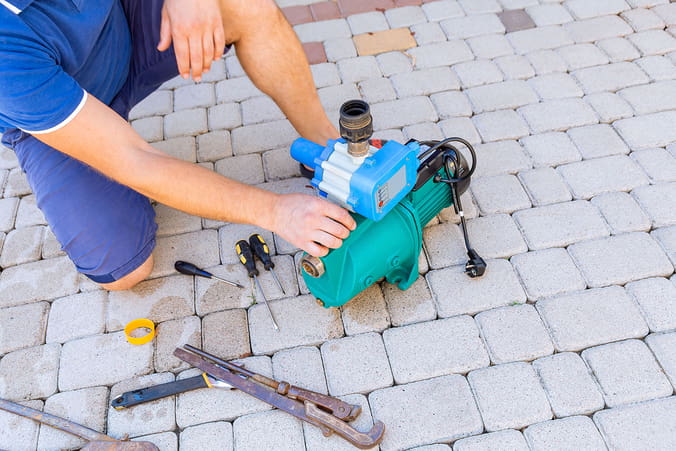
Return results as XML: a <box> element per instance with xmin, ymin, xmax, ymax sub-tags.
<box><xmin>3</xmin><ymin>0</ymin><xmax>227</xmax><ymax>283</ymax></box>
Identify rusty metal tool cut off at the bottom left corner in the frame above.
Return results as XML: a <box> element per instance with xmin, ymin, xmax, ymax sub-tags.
<box><xmin>0</xmin><ymin>398</ymin><xmax>159</xmax><ymax>451</ymax></box>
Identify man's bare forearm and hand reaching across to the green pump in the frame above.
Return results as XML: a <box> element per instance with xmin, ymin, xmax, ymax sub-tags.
<box><xmin>35</xmin><ymin>95</ymin><xmax>355</xmax><ymax>256</ymax></box>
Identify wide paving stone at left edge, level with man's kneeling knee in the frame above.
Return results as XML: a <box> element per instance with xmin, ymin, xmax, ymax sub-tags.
<box><xmin>0</xmin><ymin>257</ymin><xmax>78</xmax><ymax>307</ymax></box>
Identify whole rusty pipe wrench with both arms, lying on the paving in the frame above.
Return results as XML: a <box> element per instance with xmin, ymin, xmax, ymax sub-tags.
<box><xmin>174</xmin><ymin>345</ymin><xmax>385</xmax><ymax>449</ymax></box>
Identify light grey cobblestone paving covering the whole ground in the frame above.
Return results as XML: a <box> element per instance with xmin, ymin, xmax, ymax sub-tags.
<box><xmin>0</xmin><ymin>0</ymin><xmax>676</xmax><ymax>451</ymax></box>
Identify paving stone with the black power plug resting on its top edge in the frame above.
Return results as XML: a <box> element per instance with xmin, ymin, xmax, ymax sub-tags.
<box><xmin>427</xmin><ymin>260</ymin><xmax>526</xmax><ymax>318</ymax></box>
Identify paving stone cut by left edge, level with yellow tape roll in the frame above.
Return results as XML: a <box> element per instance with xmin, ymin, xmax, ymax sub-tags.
<box><xmin>0</xmin><ymin>302</ymin><xmax>49</xmax><ymax>354</ymax></box>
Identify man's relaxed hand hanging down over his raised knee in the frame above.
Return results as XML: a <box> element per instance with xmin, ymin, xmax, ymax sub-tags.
<box><xmin>157</xmin><ymin>0</ymin><xmax>225</xmax><ymax>82</ymax></box>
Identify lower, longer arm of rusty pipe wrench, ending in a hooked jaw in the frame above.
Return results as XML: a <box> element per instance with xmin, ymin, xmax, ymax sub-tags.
<box><xmin>174</xmin><ymin>347</ymin><xmax>385</xmax><ymax>449</ymax></box>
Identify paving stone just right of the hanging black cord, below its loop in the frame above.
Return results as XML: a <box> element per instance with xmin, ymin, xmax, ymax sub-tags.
<box><xmin>471</xmin><ymin>174</ymin><xmax>531</xmax><ymax>215</ymax></box>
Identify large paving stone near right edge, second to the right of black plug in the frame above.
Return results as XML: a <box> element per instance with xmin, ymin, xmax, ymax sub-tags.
<box><xmin>569</xmin><ymin>232</ymin><xmax>673</xmax><ymax>287</ymax></box>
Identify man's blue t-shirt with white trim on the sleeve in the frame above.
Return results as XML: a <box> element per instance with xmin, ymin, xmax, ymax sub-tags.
<box><xmin>0</xmin><ymin>0</ymin><xmax>131</xmax><ymax>134</ymax></box>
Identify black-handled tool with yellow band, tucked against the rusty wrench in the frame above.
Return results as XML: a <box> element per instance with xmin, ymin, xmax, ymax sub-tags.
<box><xmin>110</xmin><ymin>373</ymin><xmax>234</xmax><ymax>410</ymax></box>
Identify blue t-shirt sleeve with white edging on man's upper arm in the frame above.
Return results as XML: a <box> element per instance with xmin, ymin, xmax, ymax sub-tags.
<box><xmin>0</xmin><ymin>25</ymin><xmax>87</xmax><ymax>134</ymax></box>
